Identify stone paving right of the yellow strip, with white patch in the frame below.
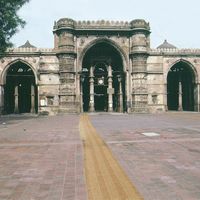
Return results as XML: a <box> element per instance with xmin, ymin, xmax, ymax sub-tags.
<box><xmin>90</xmin><ymin>112</ymin><xmax>200</xmax><ymax>200</ymax></box>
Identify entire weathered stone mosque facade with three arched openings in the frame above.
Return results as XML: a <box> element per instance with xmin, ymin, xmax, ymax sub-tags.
<box><xmin>0</xmin><ymin>18</ymin><xmax>200</xmax><ymax>115</ymax></box>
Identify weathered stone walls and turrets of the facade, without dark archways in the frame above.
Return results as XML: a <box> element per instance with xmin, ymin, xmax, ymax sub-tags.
<box><xmin>0</xmin><ymin>18</ymin><xmax>200</xmax><ymax>114</ymax></box>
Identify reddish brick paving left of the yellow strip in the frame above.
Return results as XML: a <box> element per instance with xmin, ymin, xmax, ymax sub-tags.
<box><xmin>0</xmin><ymin>115</ymin><xmax>87</xmax><ymax>200</ymax></box>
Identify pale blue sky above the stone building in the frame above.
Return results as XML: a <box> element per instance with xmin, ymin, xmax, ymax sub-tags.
<box><xmin>11</xmin><ymin>0</ymin><xmax>200</xmax><ymax>48</ymax></box>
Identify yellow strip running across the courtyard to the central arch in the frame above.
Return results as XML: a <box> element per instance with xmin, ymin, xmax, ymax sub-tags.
<box><xmin>79</xmin><ymin>114</ymin><xmax>143</xmax><ymax>200</ymax></box>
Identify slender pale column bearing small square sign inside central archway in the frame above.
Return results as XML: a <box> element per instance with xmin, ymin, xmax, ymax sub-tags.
<box><xmin>108</xmin><ymin>65</ymin><xmax>113</xmax><ymax>112</ymax></box>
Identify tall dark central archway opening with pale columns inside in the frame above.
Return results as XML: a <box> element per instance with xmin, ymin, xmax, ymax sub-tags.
<box><xmin>81</xmin><ymin>42</ymin><xmax>126</xmax><ymax>112</ymax></box>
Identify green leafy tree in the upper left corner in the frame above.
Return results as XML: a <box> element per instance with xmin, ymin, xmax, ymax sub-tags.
<box><xmin>0</xmin><ymin>0</ymin><xmax>29</xmax><ymax>54</ymax></box>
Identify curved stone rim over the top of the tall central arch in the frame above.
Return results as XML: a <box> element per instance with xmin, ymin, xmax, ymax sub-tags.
<box><xmin>79</xmin><ymin>38</ymin><xmax>128</xmax><ymax>71</ymax></box>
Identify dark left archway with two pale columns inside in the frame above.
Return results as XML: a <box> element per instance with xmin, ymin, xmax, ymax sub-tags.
<box><xmin>4</xmin><ymin>61</ymin><xmax>38</xmax><ymax>114</ymax></box>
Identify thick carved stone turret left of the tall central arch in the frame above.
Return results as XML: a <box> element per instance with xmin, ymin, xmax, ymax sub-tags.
<box><xmin>53</xmin><ymin>18</ymin><xmax>77</xmax><ymax>113</ymax></box>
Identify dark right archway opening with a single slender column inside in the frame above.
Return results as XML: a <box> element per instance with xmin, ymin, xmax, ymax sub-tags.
<box><xmin>167</xmin><ymin>61</ymin><xmax>196</xmax><ymax>111</ymax></box>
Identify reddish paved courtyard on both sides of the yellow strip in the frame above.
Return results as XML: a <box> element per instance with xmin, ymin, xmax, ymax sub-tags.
<box><xmin>0</xmin><ymin>112</ymin><xmax>200</xmax><ymax>200</ymax></box>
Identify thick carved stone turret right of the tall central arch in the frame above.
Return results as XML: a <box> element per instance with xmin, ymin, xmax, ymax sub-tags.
<box><xmin>130</xmin><ymin>19</ymin><xmax>150</xmax><ymax>112</ymax></box>
